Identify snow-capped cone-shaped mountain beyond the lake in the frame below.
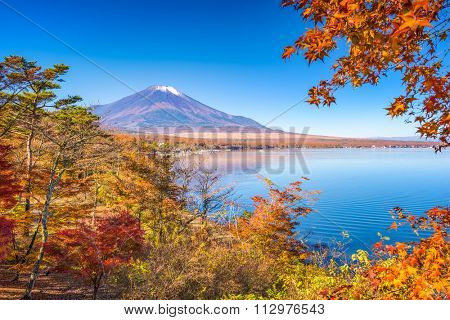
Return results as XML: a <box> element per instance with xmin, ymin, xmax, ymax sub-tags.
<box><xmin>93</xmin><ymin>86</ymin><xmax>266</xmax><ymax>131</ymax></box>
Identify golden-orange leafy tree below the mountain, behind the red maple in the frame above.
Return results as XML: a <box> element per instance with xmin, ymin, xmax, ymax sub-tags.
<box><xmin>100</xmin><ymin>137</ymin><xmax>192</xmax><ymax>243</ymax></box>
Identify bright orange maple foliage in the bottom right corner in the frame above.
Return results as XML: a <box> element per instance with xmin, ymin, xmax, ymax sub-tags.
<box><xmin>367</xmin><ymin>208</ymin><xmax>450</xmax><ymax>299</ymax></box>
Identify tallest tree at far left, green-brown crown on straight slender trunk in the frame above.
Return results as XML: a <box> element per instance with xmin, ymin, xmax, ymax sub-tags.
<box><xmin>0</xmin><ymin>57</ymin><xmax>81</xmax><ymax>212</ymax></box>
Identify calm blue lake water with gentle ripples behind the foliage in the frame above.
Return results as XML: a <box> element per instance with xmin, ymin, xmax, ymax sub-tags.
<box><xmin>191</xmin><ymin>149</ymin><xmax>450</xmax><ymax>251</ymax></box>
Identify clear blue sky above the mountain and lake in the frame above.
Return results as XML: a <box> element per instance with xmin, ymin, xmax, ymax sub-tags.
<box><xmin>0</xmin><ymin>0</ymin><xmax>415</xmax><ymax>137</ymax></box>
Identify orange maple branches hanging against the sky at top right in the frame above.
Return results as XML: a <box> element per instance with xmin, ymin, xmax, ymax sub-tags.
<box><xmin>282</xmin><ymin>0</ymin><xmax>450</xmax><ymax>148</ymax></box>
